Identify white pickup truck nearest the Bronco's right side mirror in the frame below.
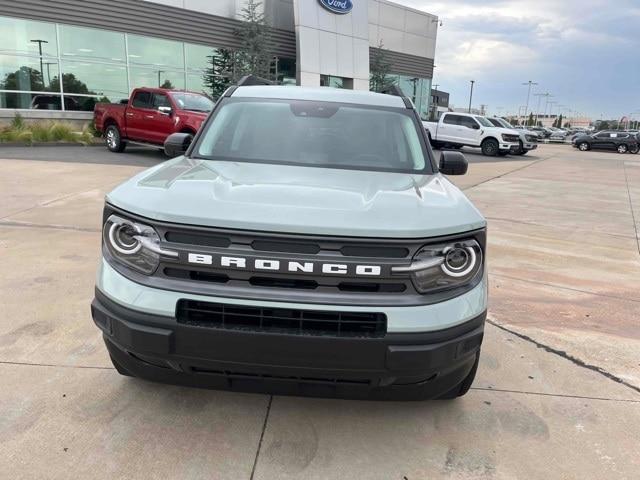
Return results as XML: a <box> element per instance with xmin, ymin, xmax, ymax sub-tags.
<box><xmin>422</xmin><ymin>112</ymin><xmax>520</xmax><ymax>157</ymax></box>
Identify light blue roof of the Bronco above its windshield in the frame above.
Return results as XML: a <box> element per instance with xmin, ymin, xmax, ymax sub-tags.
<box><xmin>231</xmin><ymin>85</ymin><xmax>406</xmax><ymax>108</ymax></box>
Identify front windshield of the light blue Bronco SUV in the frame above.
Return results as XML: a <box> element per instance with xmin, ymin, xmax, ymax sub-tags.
<box><xmin>194</xmin><ymin>99</ymin><xmax>431</xmax><ymax>173</ymax></box>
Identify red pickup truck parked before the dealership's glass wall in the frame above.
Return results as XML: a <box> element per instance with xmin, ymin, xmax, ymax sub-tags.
<box><xmin>93</xmin><ymin>88</ymin><xmax>213</xmax><ymax>152</ymax></box>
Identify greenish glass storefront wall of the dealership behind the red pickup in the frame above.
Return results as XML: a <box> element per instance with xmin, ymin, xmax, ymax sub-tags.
<box><xmin>0</xmin><ymin>17</ymin><xmax>296</xmax><ymax>111</ymax></box>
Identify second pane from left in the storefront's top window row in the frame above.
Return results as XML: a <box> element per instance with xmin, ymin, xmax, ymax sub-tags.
<box><xmin>60</xmin><ymin>25</ymin><xmax>126</xmax><ymax>63</ymax></box>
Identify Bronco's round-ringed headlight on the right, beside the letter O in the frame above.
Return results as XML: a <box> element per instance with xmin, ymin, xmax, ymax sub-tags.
<box><xmin>392</xmin><ymin>239</ymin><xmax>483</xmax><ymax>294</ymax></box>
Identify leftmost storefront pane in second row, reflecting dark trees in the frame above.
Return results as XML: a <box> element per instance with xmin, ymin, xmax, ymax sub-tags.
<box><xmin>0</xmin><ymin>55</ymin><xmax>59</xmax><ymax>92</ymax></box>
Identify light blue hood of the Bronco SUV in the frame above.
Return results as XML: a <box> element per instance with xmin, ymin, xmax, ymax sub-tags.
<box><xmin>107</xmin><ymin>157</ymin><xmax>486</xmax><ymax>238</ymax></box>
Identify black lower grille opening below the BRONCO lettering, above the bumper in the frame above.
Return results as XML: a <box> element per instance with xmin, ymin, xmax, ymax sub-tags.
<box><xmin>176</xmin><ymin>300</ymin><xmax>387</xmax><ymax>338</ymax></box>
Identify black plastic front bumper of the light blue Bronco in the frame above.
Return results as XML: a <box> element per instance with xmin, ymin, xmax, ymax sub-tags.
<box><xmin>91</xmin><ymin>290</ymin><xmax>486</xmax><ymax>400</ymax></box>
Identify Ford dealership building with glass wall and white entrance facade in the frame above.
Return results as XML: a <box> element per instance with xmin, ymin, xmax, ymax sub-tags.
<box><xmin>0</xmin><ymin>0</ymin><xmax>438</xmax><ymax>121</ymax></box>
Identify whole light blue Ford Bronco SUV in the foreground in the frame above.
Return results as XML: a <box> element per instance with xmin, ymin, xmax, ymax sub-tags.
<box><xmin>92</xmin><ymin>77</ymin><xmax>487</xmax><ymax>399</ymax></box>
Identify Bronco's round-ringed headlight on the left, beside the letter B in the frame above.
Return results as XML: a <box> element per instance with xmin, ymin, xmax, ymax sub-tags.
<box><xmin>102</xmin><ymin>215</ymin><xmax>178</xmax><ymax>275</ymax></box>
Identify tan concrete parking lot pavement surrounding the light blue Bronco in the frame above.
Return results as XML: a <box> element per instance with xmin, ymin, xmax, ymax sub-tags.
<box><xmin>0</xmin><ymin>145</ymin><xmax>640</xmax><ymax>480</ymax></box>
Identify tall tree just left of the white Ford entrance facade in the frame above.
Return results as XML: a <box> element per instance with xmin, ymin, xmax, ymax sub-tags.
<box><xmin>233</xmin><ymin>0</ymin><xmax>274</xmax><ymax>79</ymax></box>
